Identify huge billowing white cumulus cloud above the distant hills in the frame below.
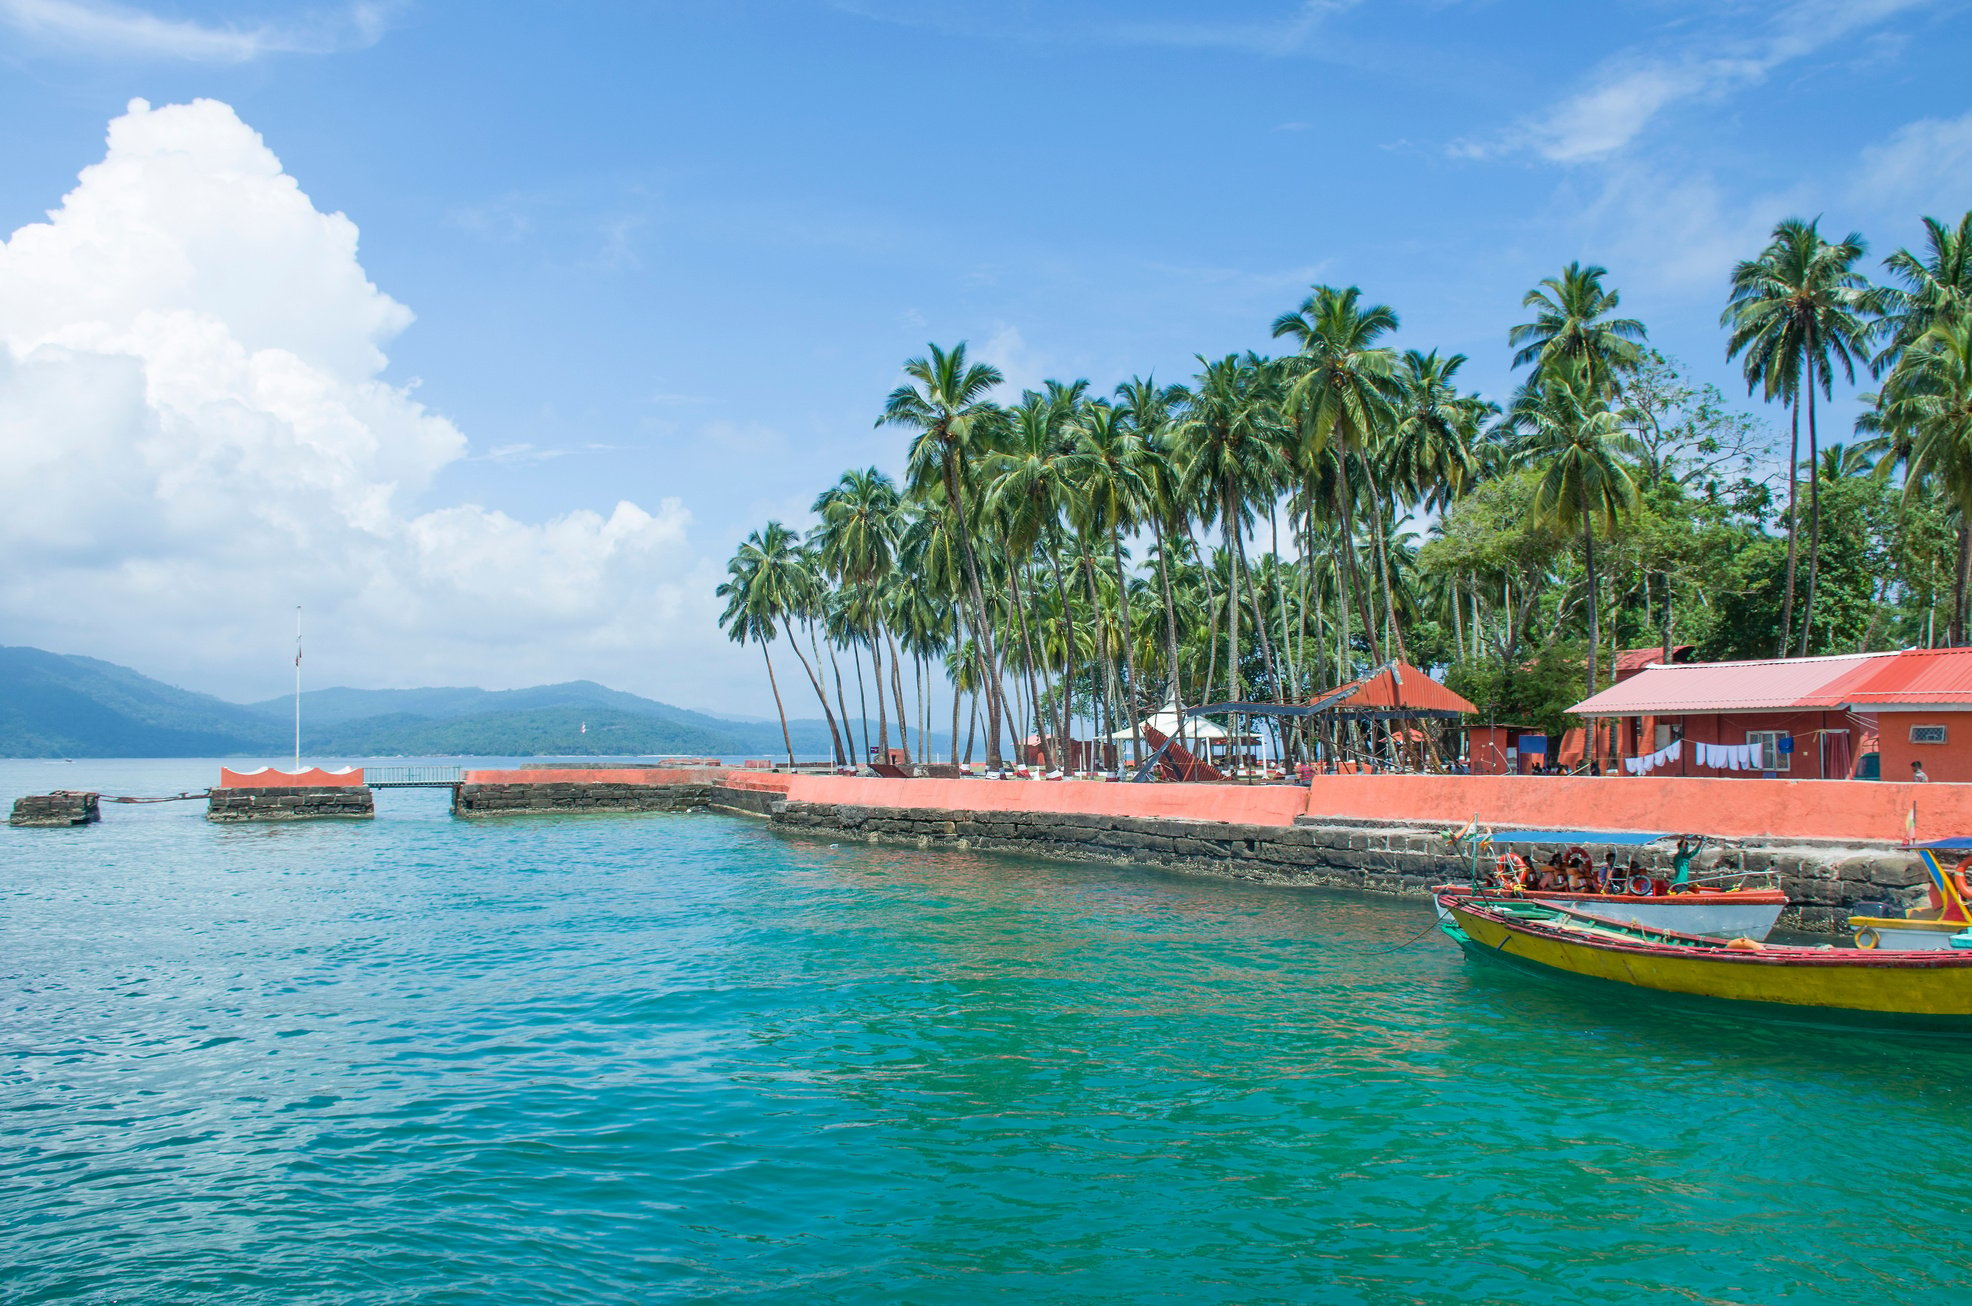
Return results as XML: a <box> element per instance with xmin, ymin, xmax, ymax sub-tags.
<box><xmin>0</xmin><ymin>101</ymin><xmax>720</xmax><ymax>698</ymax></box>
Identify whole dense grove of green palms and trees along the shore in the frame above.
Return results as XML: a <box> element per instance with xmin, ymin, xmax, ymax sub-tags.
<box><xmin>722</xmin><ymin>215</ymin><xmax>1972</xmax><ymax>765</ymax></box>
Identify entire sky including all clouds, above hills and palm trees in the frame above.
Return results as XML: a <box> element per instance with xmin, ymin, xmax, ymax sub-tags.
<box><xmin>0</xmin><ymin>0</ymin><xmax>1972</xmax><ymax>716</ymax></box>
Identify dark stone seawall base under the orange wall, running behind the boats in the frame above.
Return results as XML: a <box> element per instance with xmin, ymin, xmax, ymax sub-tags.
<box><xmin>771</xmin><ymin>801</ymin><xmax>1925</xmax><ymax>931</ymax></box>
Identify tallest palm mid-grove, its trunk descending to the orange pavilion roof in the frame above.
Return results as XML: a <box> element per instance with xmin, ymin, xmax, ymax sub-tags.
<box><xmin>1274</xmin><ymin>286</ymin><xmax>1404</xmax><ymax>661</ymax></box>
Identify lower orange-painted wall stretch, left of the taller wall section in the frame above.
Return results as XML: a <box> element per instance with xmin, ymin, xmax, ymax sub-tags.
<box><xmin>765</xmin><ymin>775</ymin><xmax>1307</xmax><ymax>825</ymax></box>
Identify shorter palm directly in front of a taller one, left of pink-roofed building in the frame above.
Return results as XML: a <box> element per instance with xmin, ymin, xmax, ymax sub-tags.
<box><xmin>1509</xmin><ymin>359</ymin><xmax>1637</xmax><ymax>694</ymax></box>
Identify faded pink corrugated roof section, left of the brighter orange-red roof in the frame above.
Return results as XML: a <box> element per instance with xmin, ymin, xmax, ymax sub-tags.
<box><xmin>1568</xmin><ymin>653</ymin><xmax>1897</xmax><ymax>716</ymax></box>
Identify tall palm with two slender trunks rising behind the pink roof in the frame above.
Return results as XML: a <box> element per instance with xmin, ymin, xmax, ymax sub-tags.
<box><xmin>1720</xmin><ymin>217</ymin><xmax>1879</xmax><ymax>655</ymax></box>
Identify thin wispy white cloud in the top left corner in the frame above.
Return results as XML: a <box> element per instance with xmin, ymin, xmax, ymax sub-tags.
<box><xmin>0</xmin><ymin>0</ymin><xmax>387</xmax><ymax>63</ymax></box>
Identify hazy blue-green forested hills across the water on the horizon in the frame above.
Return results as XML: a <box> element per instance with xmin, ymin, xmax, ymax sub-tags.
<box><xmin>0</xmin><ymin>647</ymin><xmax>879</xmax><ymax>758</ymax></box>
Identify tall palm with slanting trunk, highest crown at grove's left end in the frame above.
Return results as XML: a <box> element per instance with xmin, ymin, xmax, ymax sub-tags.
<box><xmin>876</xmin><ymin>341</ymin><xmax>1004</xmax><ymax>771</ymax></box>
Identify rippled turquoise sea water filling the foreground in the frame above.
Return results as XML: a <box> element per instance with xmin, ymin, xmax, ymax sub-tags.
<box><xmin>0</xmin><ymin>762</ymin><xmax>1972</xmax><ymax>1304</ymax></box>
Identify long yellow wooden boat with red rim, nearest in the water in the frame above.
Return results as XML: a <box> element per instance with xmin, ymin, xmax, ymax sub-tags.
<box><xmin>1440</xmin><ymin>894</ymin><xmax>1972</xmax><ymax>1030</ymax></box>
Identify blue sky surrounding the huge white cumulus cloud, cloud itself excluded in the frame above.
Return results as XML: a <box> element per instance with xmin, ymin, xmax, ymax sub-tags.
<box><xmin>0</xmin><ymin>0</ymin><xmax>1972</xmax><ymax>712</ymax></box>
